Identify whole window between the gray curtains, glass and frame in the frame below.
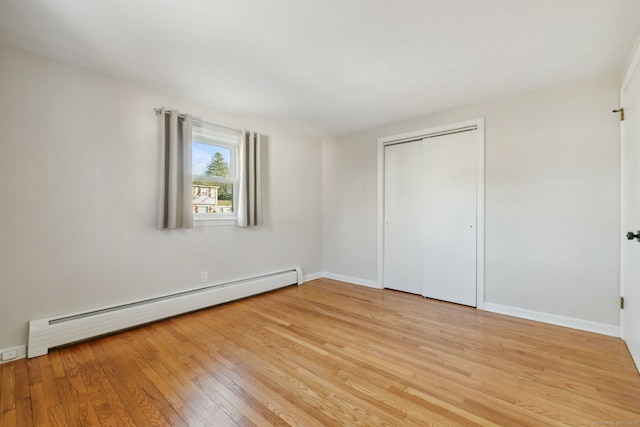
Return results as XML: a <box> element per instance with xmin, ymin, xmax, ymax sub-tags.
<box><xmin>191</xmin><ymin>122</ymin><xmax>240</xmax><ymax>220</ymax></box>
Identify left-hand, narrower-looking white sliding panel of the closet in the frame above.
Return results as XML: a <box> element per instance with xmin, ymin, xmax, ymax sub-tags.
<box><xmin>384</xmin><ymin>141</ymin><xmax>423</xmax><ymax>295</ymax></box>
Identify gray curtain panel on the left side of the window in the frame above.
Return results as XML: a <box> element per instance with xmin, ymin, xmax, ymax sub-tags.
<box><xmin>158</xmin><ymin>108</ymin><xmax>193</xmax><ymax>229</ymax></box>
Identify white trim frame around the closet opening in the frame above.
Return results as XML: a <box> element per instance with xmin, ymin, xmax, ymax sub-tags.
<box><xmin>378</xmin><ymin>117</ymin><xmax>485</xmax><ymax>309</ymax></box>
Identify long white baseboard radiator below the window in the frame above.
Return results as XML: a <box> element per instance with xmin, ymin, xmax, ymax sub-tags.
<box><xmin>27</xmin><ymin>267</ymin><xmax>303</xmax><ymax>358</ymax></box>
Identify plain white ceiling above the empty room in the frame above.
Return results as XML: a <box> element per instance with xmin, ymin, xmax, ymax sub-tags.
<box><xmin>0</xmin><ymin>0</ymin><xmax>640</xmax><ymax>136</ymax></box>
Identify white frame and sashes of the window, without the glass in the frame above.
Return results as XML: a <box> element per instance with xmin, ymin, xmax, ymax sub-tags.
<box><xmin>191</xmin><ymin>122</ymin><xmax>242</xmax><ymax>226</ymax></box>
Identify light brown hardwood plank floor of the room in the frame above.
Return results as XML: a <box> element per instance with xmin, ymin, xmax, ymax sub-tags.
<box><xmin>0</xmin><ymin>279</ymin><xmax>640</xmax><ymax>426</ymax></box>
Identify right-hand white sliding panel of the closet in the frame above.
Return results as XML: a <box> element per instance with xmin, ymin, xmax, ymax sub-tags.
<box><xmin>422</xmin><ymin>131</ymin><xmax>477</xmax><ymax>307</ymax></box>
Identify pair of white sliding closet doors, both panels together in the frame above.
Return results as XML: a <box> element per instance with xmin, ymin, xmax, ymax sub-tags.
<box><xmin>383</xmin><ymin>131</ymin><xmax>477</xmax><ymax>306</ymax></box>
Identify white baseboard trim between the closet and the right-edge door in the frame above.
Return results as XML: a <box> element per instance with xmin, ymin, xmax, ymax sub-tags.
<box><xmin>483</xmin><ymin>302</ymin><xmax>620</xmax><ymax>338</ymax></box>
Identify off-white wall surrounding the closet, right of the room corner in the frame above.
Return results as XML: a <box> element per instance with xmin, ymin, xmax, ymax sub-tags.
<box><xmin>323</xmin><ymin>75</ymin><xmax>620</xmax><ymax>328</ymax></box>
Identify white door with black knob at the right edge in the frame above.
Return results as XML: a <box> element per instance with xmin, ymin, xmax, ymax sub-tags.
<box><xmin>620</xmin><ymin>47</ymin><xmax>640</xmax><ymax>367</ymax></box>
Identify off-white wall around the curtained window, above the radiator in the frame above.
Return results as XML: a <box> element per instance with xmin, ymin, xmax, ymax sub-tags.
<box><xmin>0</xmin><ymin>47</ymin><xmax>322</xmax><ymax>349</ymax></box>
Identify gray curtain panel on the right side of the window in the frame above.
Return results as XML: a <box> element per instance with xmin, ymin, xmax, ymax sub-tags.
<box><xmin>238</xmin><ymin>132</ymin><xmax>262</xmax><ymax>227</ymax></box>
